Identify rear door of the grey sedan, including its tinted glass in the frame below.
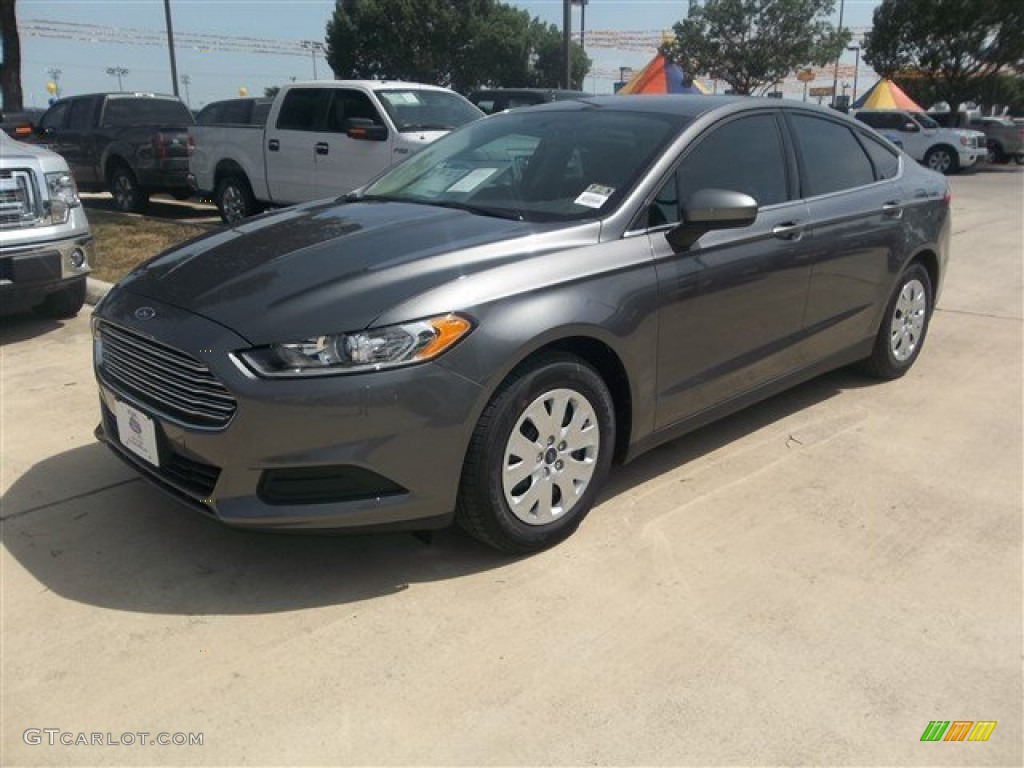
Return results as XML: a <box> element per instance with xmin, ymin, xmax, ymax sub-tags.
<box><xmin>788</xmin><ymin>113</ymin><xmax>908</xmax><ymax>360</ymax></box>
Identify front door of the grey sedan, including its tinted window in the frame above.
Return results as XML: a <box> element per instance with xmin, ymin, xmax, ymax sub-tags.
<box><xmin>647</xmin><ymin>111</ymin><xmax>810</xmax><ymax>428</ymax></box>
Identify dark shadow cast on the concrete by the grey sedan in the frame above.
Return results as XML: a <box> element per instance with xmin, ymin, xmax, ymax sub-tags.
<box><xmin>0</xmin><ymin>372</ymin><xmax>866</xmax><ymax>614</ymax></box>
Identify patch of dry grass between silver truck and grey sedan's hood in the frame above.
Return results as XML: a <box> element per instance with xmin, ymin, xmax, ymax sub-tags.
<box><xmin>87</xmin><ymin>209</ymin><xmax>209</xmax><ymax>283</ymax></box>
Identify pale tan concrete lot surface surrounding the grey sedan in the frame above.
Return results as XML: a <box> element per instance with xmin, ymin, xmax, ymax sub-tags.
<box><xmin>0</xmin><ymin>167</ymin><xmax>1024</xmax><ymax>765</ymax></box>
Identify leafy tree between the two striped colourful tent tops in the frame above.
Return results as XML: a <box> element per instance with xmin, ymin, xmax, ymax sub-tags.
<box><xmin>666</xmin><ymin>0</ymin><xmax>850</xmax><ymax>94</ymax></box>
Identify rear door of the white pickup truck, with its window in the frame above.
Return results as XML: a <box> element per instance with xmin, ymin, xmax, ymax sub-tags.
<box><xmin>263</xmin><ymin>87</ymin><xmax>331</xmax><ymax>204</ymax></box>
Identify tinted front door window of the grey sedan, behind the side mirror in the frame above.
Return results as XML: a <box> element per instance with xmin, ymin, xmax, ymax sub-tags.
<box><xmin>679</xmin><ymin>115</ymin><xmax>786</xmax><ymax>206</ymax></box>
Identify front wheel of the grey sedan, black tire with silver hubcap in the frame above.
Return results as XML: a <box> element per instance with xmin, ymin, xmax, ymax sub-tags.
<box><xmin>456</xmin><ymin>353</ymin><xmax>615</xmax><ymax>554</ymax></box>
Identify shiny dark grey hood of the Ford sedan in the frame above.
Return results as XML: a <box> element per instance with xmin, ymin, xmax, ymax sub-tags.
<box><xmin>116</xmin><ymin>202</ymin><xmax>577</xmax><ymax>344</ymax></box>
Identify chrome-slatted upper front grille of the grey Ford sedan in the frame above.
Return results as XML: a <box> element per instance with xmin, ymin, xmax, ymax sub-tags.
<box><xmin>99</xmin><ymin>323</ymin><xmax>237</xmax><ymax>429</ymax></box>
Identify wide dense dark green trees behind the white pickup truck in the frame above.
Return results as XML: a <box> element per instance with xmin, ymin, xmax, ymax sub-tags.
<box><xmin>327</xmin><ymin>0</ymin><xmax>590</xmax><ymax>91</ymax></box>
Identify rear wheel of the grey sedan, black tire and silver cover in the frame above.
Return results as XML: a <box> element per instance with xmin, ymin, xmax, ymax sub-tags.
<box><xmin>861</xmin><ymin>262</ymin><xmax>934</xmax><ymax>379</ymax></box>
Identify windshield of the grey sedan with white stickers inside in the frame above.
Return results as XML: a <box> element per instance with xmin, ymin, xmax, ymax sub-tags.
<box><xmin>361</xmin><ymin>110</ymin><xmax>688</xmax><ymax>221</ymax></box>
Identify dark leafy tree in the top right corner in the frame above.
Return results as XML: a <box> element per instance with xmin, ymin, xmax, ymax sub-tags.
<box><xmin>864</xmin><ymin>0</ymin><xmax>1024</xmax><ymax>112</ymax></box>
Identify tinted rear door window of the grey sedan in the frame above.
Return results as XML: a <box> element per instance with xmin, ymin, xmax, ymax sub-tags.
<box><xmin>792</xmin><ymin>115</ymin><xmax>874</xmax><ymax>198</ymax></box>
